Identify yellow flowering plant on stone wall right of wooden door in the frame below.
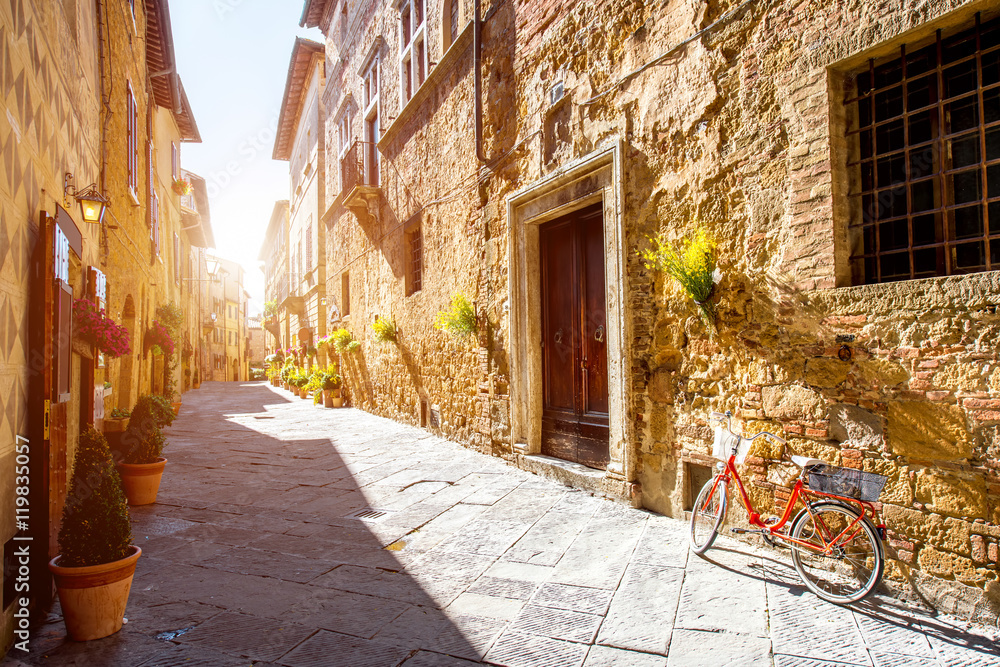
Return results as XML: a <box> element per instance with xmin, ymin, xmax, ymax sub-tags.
<box><xmin>642</xmin><ymin>226</ymin><xmax>720</xmax><ymax>327</ymax></box>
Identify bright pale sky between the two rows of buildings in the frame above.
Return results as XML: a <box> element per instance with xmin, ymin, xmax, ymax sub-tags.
<box><xmin>170</xmin><ymin>0</ymin><xmax>323</xmax><ymax>313</ymax></box>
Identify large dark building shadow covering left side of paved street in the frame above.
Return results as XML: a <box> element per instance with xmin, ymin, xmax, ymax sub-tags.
<box><xmin>20</xmin><ymin>383</ymin><xmax>482</xmax><ymax>667</ymax></box>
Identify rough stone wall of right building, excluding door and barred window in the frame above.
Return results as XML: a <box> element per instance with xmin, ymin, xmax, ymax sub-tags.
<box><xmin>312</xmin><ymin>0</ymin><xmax>1000</xmax><ymax>618</ymax></box>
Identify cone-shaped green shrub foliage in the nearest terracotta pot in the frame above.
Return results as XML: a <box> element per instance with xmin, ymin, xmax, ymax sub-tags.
<box><xmin>59</xmin><ymin>426</ymin><xmax>132</xmax><ymax>567</ymax></box>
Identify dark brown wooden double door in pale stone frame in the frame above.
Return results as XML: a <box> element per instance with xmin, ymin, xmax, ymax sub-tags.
<box><xmin>539</xmin><ymin>204</ymin><xmax>609</xmax><ymax>469</ymax></box>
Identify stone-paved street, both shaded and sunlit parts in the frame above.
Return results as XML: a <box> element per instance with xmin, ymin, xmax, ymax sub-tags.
<box><xmin>5</xmin><ymin>383</ymin><xmax>1000</xmax><ymax>667</ymax></box>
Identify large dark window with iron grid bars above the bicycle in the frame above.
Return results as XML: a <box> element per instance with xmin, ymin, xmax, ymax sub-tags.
<box><xmin>845</xmin><ymin>15</ymin><xmax>1000</xmax><ymax>284</ymax></box>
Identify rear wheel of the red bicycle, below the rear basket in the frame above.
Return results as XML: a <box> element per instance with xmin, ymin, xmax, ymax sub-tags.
<box><xmin>791</xmin><ymin>502</ymin><xmax>885</xmax><ymax>604</ymax></box>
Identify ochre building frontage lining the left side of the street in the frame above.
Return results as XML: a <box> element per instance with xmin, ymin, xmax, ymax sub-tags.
<box><xmin>0</xmin><ymin>0</ymin><xmax>208</xmax><ymax>649</ymax></box>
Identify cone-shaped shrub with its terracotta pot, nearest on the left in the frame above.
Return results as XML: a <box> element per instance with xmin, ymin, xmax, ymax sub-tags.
<box><xmin>49</xmin><ymin>427</ymin><xmax>142</xmax><ymax>641</ymax></box>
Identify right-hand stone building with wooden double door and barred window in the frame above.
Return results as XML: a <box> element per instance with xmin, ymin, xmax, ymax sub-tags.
<box><xmin>292</xmin><ymin>0</ymin><xmax>1000</xmax><ymax>618</ymax></box>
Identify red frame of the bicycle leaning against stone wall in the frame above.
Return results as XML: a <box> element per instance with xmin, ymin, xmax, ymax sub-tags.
<box><xmin>709</xmin><ymin>453</ymin><xmax>877</xmax><ymax>555</ymax></box>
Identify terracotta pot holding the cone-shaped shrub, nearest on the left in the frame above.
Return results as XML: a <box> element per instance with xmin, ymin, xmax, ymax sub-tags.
<box><xmin>49</xmin><ymin>545</ymin><xmax>142</xmax><ymax>642</ymax></box>
